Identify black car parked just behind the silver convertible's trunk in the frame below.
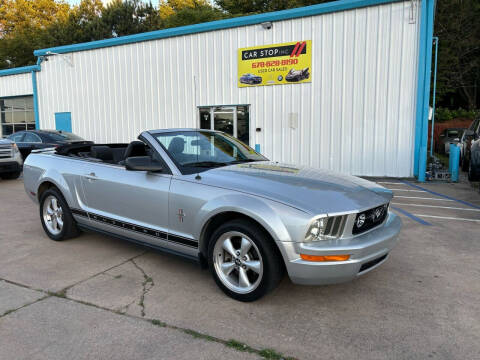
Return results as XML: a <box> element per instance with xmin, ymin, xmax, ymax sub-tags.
<box><xmin>8</xmin><ymin>130</ymin><xmax>93</xmax><ymax>160</ymax></box>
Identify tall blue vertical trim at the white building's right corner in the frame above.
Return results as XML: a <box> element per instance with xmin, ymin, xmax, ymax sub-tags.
<box><xmin>413</xmin><ymin>0</ymin><xmax>435</xmax><ymax>182</ymax></box>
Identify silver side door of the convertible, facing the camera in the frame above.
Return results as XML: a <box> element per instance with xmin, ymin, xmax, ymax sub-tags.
<box><xmin>82</xmin><ymin>143</ymin><xmax>172</xmax><ymax>245</ymax></box>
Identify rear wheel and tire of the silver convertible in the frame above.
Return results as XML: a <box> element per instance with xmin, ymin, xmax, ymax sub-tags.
<box><xmin>40</xmin><ymin>188</ymin><xmax>79</xmax><ymax>241</ymax></box>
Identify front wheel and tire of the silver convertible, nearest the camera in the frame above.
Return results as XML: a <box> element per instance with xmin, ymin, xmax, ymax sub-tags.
<box><xmin>208</xmin><ymin>219</ymin><xmax>284</xmax><ymax>302</ymax></box>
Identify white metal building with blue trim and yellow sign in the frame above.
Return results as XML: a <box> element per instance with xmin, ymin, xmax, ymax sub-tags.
<box><xmin>0</xmin><ymin>0</ymin><xmax>434</xmax><ymax>180</ymax></box>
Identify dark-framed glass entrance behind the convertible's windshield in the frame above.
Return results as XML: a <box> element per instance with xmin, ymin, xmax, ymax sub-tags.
<box><xmin>198</xmin><ymin>105</ymin><xmax>250</xmax><ymax>145</ymax></box>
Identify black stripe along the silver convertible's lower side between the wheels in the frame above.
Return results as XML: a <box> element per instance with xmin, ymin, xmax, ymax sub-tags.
<box><xmin>70</xmin><ymin>209</ymin><xmax>198</xmax><ymax>248</ymax></box>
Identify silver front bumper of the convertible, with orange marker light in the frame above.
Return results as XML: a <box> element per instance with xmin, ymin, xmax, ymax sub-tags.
<box><xmin>277</xmin><ymin>213</ymin><xmax>402</xmax><ymax>285</ymax></box>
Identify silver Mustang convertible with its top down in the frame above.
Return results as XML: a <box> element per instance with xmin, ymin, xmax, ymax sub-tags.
<box><xmin>24</xmin><ymin>129</ymin><xmax>401</xmax><ymax>301</ymax></box>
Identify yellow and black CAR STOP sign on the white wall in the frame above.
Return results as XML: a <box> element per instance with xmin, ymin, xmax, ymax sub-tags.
<box><xmin>238</xmin><ymin>40</ymin><xmax>312</xmax><ymax>87</ymax></box>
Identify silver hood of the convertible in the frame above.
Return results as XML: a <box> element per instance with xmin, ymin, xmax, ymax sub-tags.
<box><xmin>195</xmin><ymin>161</ymin><xmax>393</xmax><ymax>215</ymax></box>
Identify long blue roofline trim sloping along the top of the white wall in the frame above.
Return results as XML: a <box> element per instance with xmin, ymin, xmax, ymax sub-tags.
<box><xmin>33</xmin><ymin>0</ymin><xmax>402</xmax><ymax>56</ymax></box>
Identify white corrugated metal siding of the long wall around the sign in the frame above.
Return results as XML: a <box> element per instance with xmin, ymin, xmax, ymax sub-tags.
<box><xmin>38</xmin><ymin>1</ymin><xmax>419</xmax><ymax>176</ymax></box>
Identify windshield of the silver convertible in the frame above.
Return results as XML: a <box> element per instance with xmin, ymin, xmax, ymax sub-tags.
<box><xmin>154</xmin><ymin>130</ymin><xmax>268</xmax><ymax>173</ymax></box>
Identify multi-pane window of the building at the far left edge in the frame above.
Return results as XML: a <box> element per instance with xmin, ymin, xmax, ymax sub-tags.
<box><xmin>0</xmin><ymin>96</ymin><xmax>35</xmax><ymax>136</ymax></box>
